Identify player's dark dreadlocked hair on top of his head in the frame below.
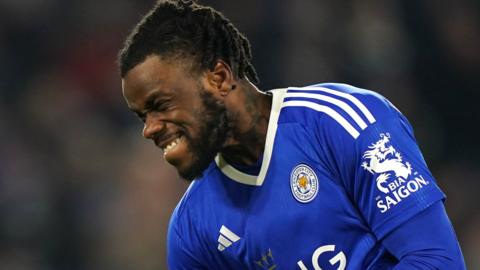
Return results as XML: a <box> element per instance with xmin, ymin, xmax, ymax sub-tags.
<box><xmin>119</xmin><ymin>0</ymin><xmax>258</xmax><ymax>83</ymax></box>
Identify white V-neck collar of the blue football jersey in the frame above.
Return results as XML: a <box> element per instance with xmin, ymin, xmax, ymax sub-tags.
<box><xmin>215</xmin><ymin>88</ymin><xmax>287</xmax><ymax>186</ymax></box>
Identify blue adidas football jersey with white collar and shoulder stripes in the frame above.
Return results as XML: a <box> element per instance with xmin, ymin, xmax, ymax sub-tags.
<box><xmin>168</xmin><ymin>84</ymin><xmax>445</xmax><ymax>270</ymax></box>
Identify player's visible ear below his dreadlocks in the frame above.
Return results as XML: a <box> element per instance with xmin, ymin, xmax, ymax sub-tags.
<box><xmin>206</xmin><ymin>59</ymin><xmax>236</xmax><ymax>96</ymax></box>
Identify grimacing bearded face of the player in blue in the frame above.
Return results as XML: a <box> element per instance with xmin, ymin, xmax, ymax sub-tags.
<box><xmin>122</xmin><ymin>56</ymin><xmax>228</xmax><ymax>180</ymax></box>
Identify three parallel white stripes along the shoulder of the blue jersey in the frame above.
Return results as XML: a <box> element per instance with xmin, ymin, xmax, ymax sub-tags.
<box><xmin>283</xmin><ymin>87</ymin><xmax>376</xmax><ymax>139</ymax></box>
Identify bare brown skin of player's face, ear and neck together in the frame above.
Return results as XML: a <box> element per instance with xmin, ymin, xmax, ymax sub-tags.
<box><xmin>122</xmin><ymin>55</ymin><xmax>272</xmax><ymax>178</ymax></box>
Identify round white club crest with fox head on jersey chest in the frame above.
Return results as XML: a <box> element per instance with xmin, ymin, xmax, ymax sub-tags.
<box><xmin>290</xmin><ymin>164</ymin><xmax>318</xmax><ymax>203</ymax></box>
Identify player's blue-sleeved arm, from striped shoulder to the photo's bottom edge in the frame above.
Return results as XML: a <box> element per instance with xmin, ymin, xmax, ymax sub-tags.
<box><xmin>302</xmin><ymin>86</ymin><xmax>465</xmax><ymax>269</ymax></box>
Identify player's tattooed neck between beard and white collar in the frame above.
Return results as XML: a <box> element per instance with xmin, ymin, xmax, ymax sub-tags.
<box><xmin>221</xmin><ymin>81</ymin><xmax>272</xmax><ymax>165</ymax></box>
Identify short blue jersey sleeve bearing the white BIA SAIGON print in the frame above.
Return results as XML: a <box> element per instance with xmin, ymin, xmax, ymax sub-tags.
<box><xmin>318</xmin><ymin>85</ymin><xmax>445</xmax><ymax>239</ymax></box>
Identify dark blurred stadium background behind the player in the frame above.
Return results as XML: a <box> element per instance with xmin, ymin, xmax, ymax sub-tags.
<box><xmin>0</xmin><ymin>0</ymin><xmax>480</xmax><ymax>270</ymax></box>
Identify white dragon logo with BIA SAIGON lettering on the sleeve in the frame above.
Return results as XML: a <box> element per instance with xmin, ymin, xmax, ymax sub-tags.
<box><xmin>362</xmin><ymin>133</ymin><xmax>429</xmax><ymax>213</ymax></box>
